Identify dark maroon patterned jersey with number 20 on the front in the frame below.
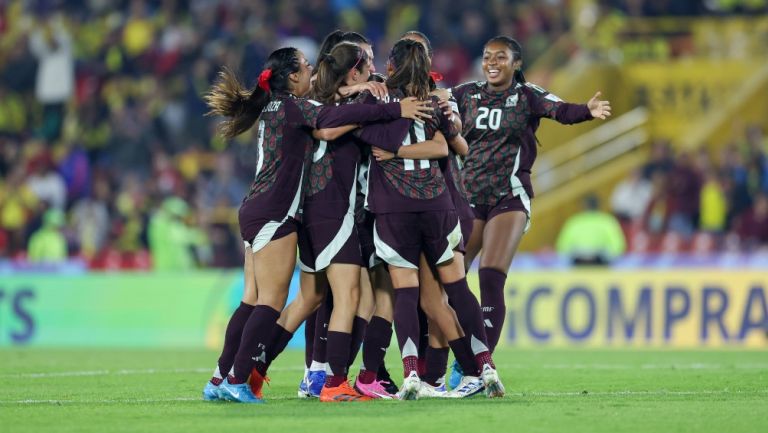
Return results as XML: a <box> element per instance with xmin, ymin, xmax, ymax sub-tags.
<box><xmin>452</xmin><ymin>81</ymin><xmax>592</xmax><ymax>206</ymax></box>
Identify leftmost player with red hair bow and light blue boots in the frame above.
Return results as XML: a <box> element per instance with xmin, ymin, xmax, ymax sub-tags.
<box><xmin>203</xmin><ymin>48</ymin><xmax>432</xmax><ymax>403</ymax></box>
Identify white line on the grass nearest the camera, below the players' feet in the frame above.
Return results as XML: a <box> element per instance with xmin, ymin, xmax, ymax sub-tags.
<box><xmin>6</xmin><ymin>389</ymin><xmax>768</xmax><ymax>406</ymax></box>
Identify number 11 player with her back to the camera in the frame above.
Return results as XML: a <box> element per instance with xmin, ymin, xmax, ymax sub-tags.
<box><xmin>357</xmin><ymin>40</ymin><xmax>504</xmax><ymax>399</ymax></box>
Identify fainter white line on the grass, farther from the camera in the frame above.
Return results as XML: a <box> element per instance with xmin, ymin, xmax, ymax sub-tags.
<box><xmin>6</xmin><ymin>363</ymin><xmax>768</xmax><ymax>379</ymax></box>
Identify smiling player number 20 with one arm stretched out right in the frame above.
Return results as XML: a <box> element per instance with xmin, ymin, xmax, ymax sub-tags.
<box><xmin>452</xmin><ymin>36</ymin><xmax>611</xmax><ymax>350</ymax></box>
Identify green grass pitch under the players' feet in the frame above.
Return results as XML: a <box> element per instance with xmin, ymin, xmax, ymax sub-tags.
<box><xmin>0</xmin><ymin>346</ymin><xmax>768</xmax><ymax>433</ymax></box>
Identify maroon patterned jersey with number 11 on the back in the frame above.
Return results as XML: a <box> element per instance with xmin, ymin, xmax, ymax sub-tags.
<box><xmin>358</xmin><ymin>89</ymin><xmax>453</xmax><ymax>214</ymax></box>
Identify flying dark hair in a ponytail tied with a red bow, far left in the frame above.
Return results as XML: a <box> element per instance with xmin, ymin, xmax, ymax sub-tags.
<box><xmin>203</xmin><ymin>47</ymin><xmax>299</xmax><ymax>138</ymax></box>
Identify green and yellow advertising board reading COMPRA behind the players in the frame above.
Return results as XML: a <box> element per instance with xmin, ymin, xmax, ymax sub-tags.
<box><xmin>0</xmin><ymin>270</ymin><xmax>768</xmax><ymax>349</ymax></box>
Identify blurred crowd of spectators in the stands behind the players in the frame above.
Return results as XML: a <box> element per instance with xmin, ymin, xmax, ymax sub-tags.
<box><xmin>0</xmin><ymin>0</ymin><xmax>768</xmax><ymax>268</ymax></box>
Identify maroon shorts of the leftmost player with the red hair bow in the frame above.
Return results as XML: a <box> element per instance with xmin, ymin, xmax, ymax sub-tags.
<box><xmin>238</xmin><ymin>201</ymin><xmax>299</xmax><ymax>253</ymax></box>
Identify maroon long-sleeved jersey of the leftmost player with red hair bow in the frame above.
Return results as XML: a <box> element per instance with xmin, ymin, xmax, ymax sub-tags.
<box><xmin>246</xmin><ymin>94</ymin><xmax>400</xmax><ymax>221</ymax></box>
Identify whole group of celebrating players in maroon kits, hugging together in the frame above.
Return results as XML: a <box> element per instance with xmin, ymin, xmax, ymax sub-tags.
<box><xmin>203</xmin><ymin>31</ymin><xmax>610</xmax><ymax>403</ymax></box>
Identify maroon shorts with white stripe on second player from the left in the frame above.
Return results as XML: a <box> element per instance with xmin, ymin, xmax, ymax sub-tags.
<box><xmin>299</xmin><ymin>219</ymin><xmax>363</xmax><ymax>272</ymax></box>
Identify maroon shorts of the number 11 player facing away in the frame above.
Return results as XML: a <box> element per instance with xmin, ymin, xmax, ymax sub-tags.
<box><xmin>374</xmin><ymin>210</ymin><xmax>464</xmax><ymax>269</ymax></box>
